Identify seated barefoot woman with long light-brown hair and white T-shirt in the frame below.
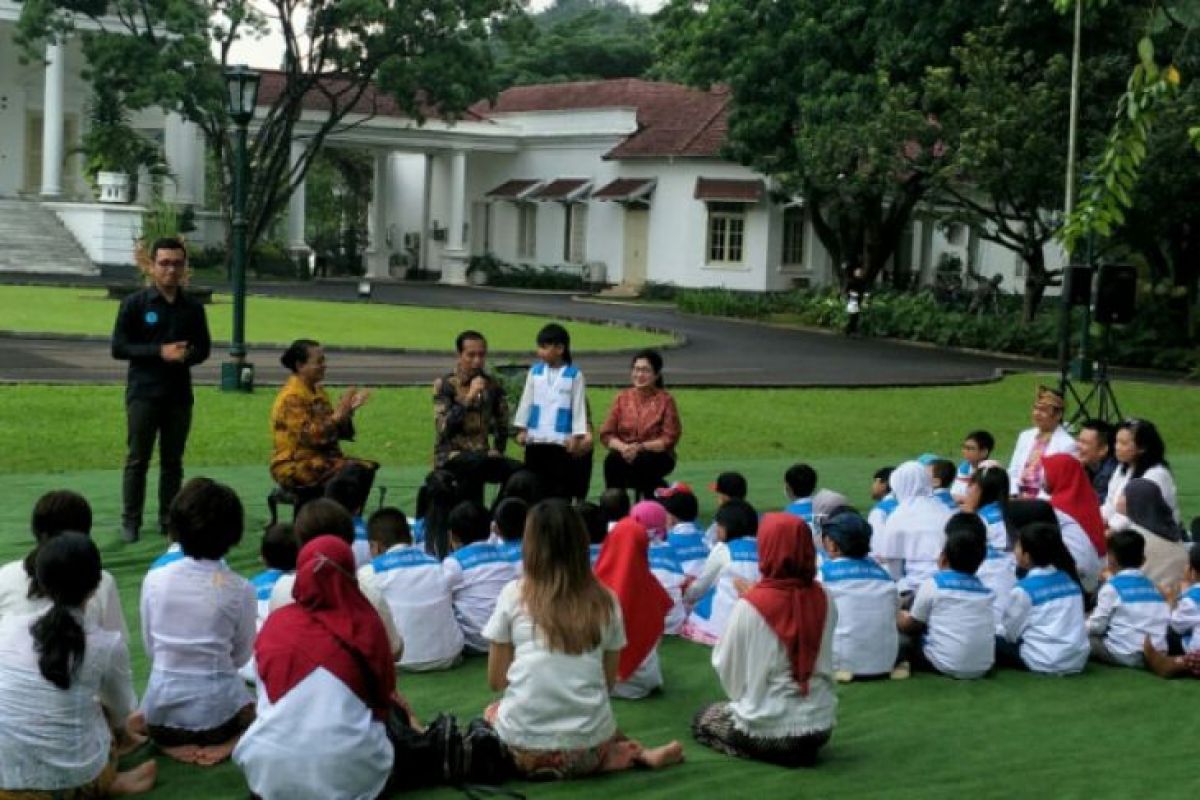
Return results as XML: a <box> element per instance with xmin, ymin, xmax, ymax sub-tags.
<box><xmin>484</xmin><ymin>500</ymin><xmax>683</xmax><ymax>780</ymax></box>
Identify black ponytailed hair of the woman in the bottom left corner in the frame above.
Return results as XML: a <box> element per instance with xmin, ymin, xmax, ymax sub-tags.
<box><xmin>30</xmin><ymin>531</ymin><xmax>101</xmax><ymax>690</ymax></box>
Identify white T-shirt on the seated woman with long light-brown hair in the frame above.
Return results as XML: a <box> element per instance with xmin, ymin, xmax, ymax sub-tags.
<box><xmin>484</xmin><ymin>581</ymin><xmax>625</xmax><ymax>750</ymax></box>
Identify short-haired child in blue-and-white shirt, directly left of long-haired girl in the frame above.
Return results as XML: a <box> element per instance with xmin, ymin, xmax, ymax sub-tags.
<box><xmin>896</xmin><ymin>520</ymin><xmax>996</xmax><ymax>680</ymax></box>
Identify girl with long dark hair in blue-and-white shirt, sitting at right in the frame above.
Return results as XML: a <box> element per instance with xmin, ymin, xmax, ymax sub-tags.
<box><xmin>996</xmin><ymin>523</ymin><xmax>1090</xmax><ymax>675</ymax></box>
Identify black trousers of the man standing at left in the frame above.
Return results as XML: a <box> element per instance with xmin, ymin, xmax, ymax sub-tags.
<box><xmin>121</xmin><ymin>398</ymin><xmax>192</xmax><ymax>530</ymax></box>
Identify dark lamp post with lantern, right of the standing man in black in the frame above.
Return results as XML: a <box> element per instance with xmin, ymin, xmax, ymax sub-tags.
<box><xmin>221</xmin><ymin>65</ymin><xmax>259</xmax><ymax>392</ymax></box>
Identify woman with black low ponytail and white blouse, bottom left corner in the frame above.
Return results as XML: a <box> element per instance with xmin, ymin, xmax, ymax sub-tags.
<box><xmin>0</xmin><ymin>533</ymin><xmax>156</xmax><ymax>796</ymax></box>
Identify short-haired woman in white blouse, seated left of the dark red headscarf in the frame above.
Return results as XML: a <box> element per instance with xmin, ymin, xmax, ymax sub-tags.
<box><xmin>142</xmin><ymin>477</ymin><xmax>257</xmax><ymax>766</ymax></box>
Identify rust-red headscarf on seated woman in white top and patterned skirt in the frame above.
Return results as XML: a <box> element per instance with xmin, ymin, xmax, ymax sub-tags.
<box><xmin>744</xmin><ymin>512</ymin><xmax>828</xmax><ymax>694</ymax></box>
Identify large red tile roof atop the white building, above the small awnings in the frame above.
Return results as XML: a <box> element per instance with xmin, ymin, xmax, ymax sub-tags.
<box><xmin>472</xmin><ymin>78</ymin><xmax>730</xmax><ymax>158</ymax></box>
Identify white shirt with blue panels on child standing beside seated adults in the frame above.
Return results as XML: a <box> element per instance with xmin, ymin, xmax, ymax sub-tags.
<box><xmin>512</xmin><ymin>362</ymin><xmax>588</xmax><ymax>445</ymax></box>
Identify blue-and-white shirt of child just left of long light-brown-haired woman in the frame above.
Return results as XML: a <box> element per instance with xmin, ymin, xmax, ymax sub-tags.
<box><xmin>442</xmin><ymin>542</ymin><xmax>521</xmax><ymax>652</ymax></box>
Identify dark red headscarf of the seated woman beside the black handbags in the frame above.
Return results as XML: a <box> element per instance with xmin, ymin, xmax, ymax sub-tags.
<box><xmin>254</xmin><ymin>536</ymin><xmax>396</xmax><ymax>720</ymax></box>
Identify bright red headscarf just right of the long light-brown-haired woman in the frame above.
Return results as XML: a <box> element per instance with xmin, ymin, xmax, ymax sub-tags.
<box><xmin>595</xmin><ymin>517</ymin><xmax>673</xmax><ymax>680</ymax></box>
